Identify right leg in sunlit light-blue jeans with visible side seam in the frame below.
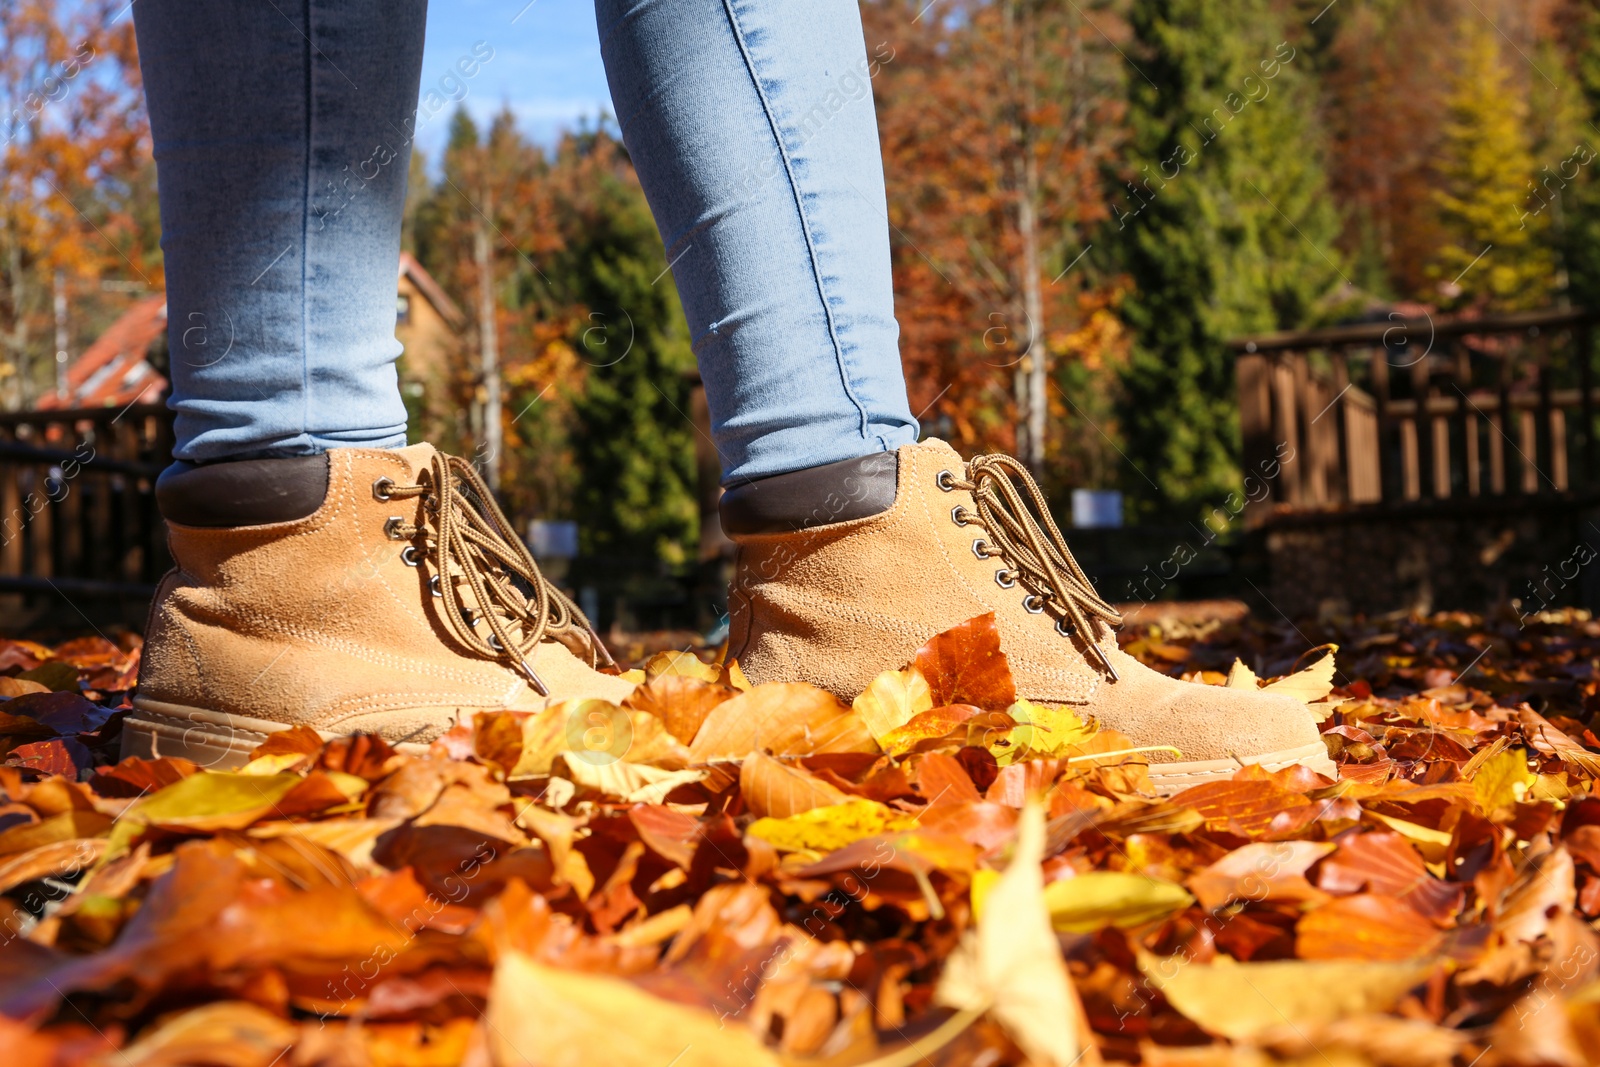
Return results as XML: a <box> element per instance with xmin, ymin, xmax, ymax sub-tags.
<box><xmin>595</xmin><ymin>0</ymin><xmax>917</xmax><ymax>485</ymax></box>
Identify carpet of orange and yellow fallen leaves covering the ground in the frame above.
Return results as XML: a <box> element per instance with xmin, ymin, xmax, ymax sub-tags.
<box><xmin>0</xmin><ymin>614</ymin><xmax>1600</xmax><ymax>1067</ymax></box>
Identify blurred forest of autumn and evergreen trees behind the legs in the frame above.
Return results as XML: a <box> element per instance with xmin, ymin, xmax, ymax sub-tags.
<box><xmin>0</xmin><ymin>0</ymin><xmax>1600</xmax><ymax>571</ymax></box>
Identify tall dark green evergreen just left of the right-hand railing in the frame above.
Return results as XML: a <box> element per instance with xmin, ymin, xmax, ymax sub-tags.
<box><xmin>1101</xmin><ymin>0</ymin><xmax>1342</xmax><ymax>518</ymax></box>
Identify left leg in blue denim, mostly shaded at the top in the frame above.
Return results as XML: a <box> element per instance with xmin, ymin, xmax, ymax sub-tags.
<box><xmin>133</xmin><ymin>0</ymin><xmax>427</xmax><ymax>462</ymax></box>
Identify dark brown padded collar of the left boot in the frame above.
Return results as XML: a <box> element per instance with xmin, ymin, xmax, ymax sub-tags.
<box><xmin>155</xmin><ymin>454</ymin><xmax>328</xmax><ymax>526</ymax></box>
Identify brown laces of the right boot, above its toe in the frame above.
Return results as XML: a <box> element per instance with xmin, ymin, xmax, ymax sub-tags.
<box><xmin>938</xmin><ymin>454</ymin><xmax>1122</xmax><ymax>681</ymax></box>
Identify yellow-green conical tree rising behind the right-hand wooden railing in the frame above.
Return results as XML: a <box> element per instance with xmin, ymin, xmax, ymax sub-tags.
<box><xmin>1434</xmin><ymin>18</ymin><xmax>1557</xmax><ymax>310</ymax></box>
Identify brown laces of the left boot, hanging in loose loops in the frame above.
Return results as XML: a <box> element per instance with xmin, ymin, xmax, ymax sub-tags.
<box><xmin>373</xmin><ymin>453</ymin><xmax>616</xmax><ymax>696</ymax></box>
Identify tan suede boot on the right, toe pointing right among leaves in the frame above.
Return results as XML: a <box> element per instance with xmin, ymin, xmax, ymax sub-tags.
<box><xmin>723</xmin><ymin>440</ymin><xmax>1336</xmax><ymax>792</ymax></box>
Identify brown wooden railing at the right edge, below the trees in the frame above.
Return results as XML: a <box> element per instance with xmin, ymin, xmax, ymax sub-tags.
<box><xmin>1229</xmin><ymin>309</ymin><xmax>1600</xmax><ymax>507</ymax></box>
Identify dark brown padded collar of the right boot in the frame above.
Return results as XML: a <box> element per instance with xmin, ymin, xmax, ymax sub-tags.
<box><xmin>717</xmin><ymin>453</ymin><xmax>899</xmax><ymax>537</ymax></box>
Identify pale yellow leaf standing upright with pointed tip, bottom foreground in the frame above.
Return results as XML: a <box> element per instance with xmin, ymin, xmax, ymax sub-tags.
<box><xmin>934</xmin><ymin>803</ymin><xmax>1088</xmax><ymax>1067</ymax></box>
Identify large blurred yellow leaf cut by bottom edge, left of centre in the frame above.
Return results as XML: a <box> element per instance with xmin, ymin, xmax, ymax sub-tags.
<box><xmin>486</xmin><ymin>952</ymin><xmax>778</xmax><ymax>1067</ymax></box>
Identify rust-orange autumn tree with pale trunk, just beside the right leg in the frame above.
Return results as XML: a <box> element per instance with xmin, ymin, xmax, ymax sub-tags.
<box><xmin>864</xmin><ymin>0</ymin><xmax>1122</xmax><ymax>470</ymax></box>
